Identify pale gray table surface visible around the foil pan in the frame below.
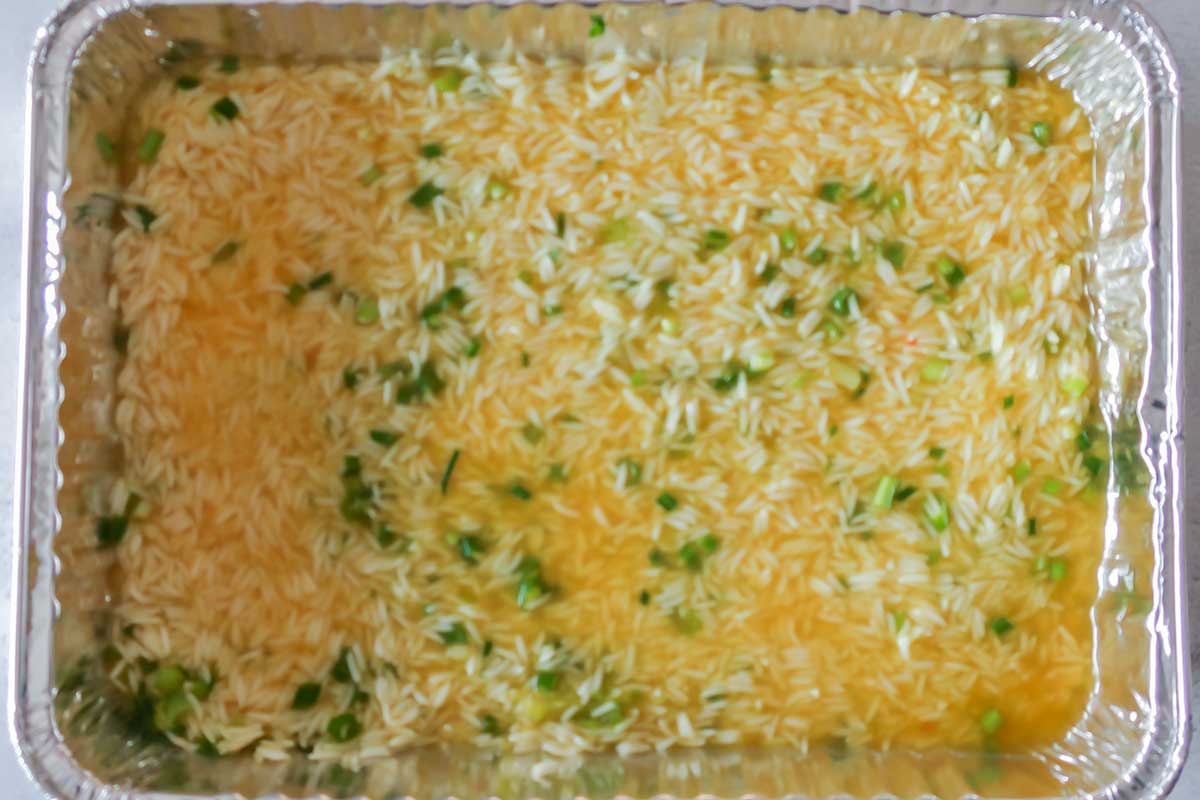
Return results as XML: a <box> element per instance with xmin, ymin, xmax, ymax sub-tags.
<box><xmin>0</xmin><ymin>0</ymin><xmax>1200</xmax><ymax>800</ymax></box>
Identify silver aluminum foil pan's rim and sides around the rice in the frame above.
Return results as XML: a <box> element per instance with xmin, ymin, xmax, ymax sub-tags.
<box><xmin>10</xmin><ymin>0</ymin><xmax>1188</xmax><ymax>800</ymax></box>
